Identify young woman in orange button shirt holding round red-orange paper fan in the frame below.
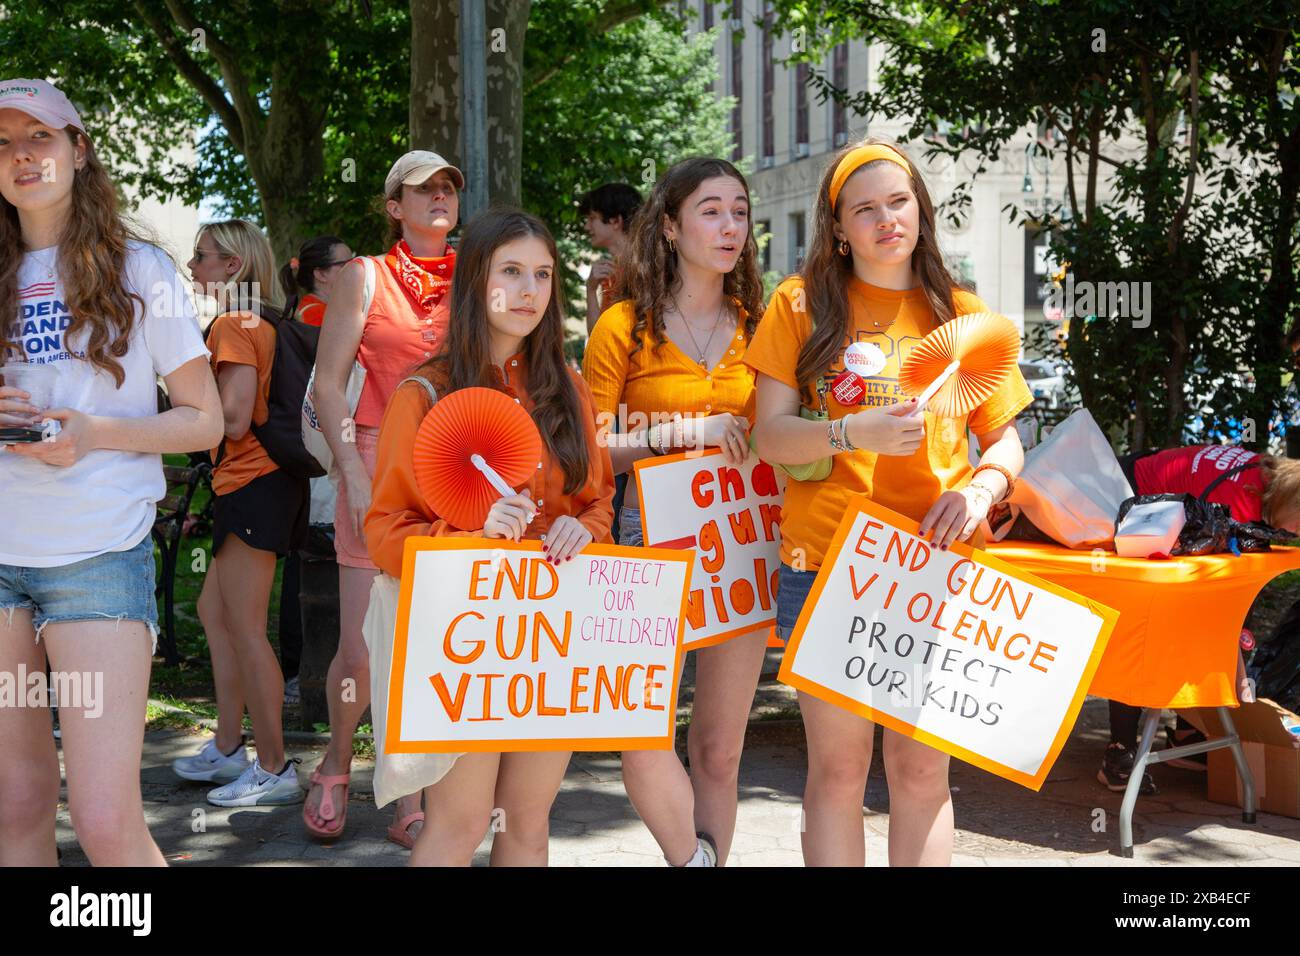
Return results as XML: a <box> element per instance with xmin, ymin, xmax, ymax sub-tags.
<box><xmin>365</xmin><ymin>209</ymin><xmax>614</xmax><ymax>866</ymax></box>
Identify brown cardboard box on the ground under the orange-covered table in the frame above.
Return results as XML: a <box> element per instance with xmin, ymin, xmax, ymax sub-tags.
<box><xmin>1180</xmin><ymin>700</ymin><xmax>1300</xmax><ymax>818</ymax></box>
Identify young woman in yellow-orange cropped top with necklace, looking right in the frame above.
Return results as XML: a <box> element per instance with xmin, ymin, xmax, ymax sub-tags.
<box><xmin>582</xmin><ymin>159</ymin><xmax>767</xmax><ymax>866</ymax></box>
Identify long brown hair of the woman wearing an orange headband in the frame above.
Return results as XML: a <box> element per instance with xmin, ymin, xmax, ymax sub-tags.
<box><xmin>794</xmin><ymin>139</ymin><xmax>958</xmax><ymax>401</ymax></box>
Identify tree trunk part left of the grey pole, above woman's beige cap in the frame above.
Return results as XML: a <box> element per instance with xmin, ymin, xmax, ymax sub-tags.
<box><xmin>410</xmin><ymin>0</ymin><xmax>465</xmax><ymax>166</ymax></box>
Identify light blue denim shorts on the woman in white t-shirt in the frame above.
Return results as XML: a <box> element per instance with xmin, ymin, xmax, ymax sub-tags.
<box><xmin>0</xmin><ymin>535</ymin><xmax>159</xmax><ymax>643</ymax></box>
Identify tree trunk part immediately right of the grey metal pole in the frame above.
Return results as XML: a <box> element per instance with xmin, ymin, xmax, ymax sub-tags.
<box><xmin>488</xmin><ymin>0</ymin><xmax>532</xmax><ymax>206</ymax></box>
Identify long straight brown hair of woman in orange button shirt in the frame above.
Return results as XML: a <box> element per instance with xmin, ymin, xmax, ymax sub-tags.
<box><xmin>417</xmin><ymin>207</ymin><xmax>592</xmax><ymax>494</ymax></box>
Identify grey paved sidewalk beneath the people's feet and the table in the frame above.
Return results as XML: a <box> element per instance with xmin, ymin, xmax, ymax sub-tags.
<box><xmin>59</xmin><ymin>688</ymin><xmax>1300</xmax><ymax>866</ymax></box>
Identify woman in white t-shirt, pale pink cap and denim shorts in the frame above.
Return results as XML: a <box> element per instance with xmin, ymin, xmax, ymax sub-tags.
<box><xmin>0</xmin><ymin>79</ymin><xmax>222</xmax><ymax>866</ymax></box>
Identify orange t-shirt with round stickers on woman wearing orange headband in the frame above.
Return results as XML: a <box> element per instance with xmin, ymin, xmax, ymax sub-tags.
<box><xmin>745</xmin><ymin>276</ymin><xmax>1034</xmax><ymax>570</ymax></box>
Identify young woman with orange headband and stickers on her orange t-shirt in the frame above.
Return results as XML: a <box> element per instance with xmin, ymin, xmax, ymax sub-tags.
<box><xmin>745</xmin><ymin>142</ymin><xmax>1032</xmax><ymax>866</ymax></box>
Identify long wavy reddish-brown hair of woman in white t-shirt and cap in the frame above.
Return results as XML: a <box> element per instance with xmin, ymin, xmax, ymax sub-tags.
<box><xmin>0</xmin><ymin>126</ymin><xmax>147</xmax><ymax>388</ymax></box>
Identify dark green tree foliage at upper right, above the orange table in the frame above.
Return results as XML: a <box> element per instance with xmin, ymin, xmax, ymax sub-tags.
<box><xmin>777</xmin><ymin>0</ymin><xmax>1300</xmax><ymax>447</ymax></box>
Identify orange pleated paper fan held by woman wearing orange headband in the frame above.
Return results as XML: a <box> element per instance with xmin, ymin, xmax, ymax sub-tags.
<box><xmin>898</xmin><ymin>312</ymin><xmax>1021</xmax><ymax>419</ymax></box>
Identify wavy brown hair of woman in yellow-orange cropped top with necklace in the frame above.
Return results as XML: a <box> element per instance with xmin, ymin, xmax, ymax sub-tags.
<box><xmin>614</xmin><ymin>156</ymin><xmax>763</xmax><ymax>355</ymax></box>
